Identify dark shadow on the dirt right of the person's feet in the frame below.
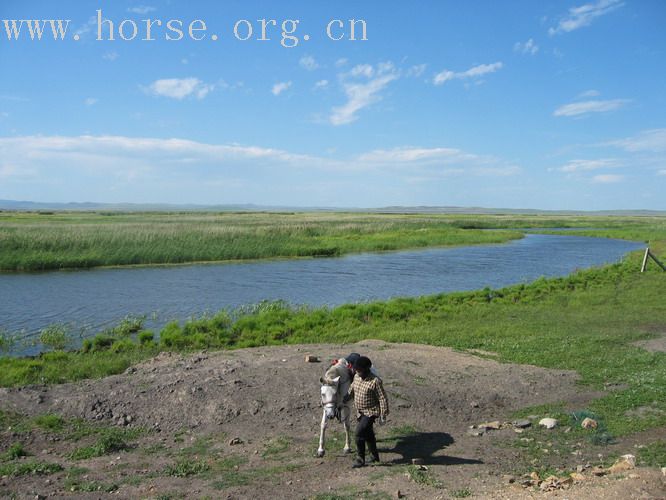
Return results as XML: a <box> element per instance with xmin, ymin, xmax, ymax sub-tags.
<box><xmin>377</xmin><ymin>432</ymin><xmax>483</xmax><ymax>465</ymax></box>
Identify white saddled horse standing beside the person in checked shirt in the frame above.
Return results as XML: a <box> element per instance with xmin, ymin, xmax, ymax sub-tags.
<box><xmin>317</xmin><ymin>358</ymin><xmax>352</xmax><ymax>457</ymax></box>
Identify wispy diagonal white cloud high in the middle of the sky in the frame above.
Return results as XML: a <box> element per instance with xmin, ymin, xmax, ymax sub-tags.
<box><xmin>329</xmin><ymin>62</ymin><xmax>400</xmax><ymax>126</ymax></box>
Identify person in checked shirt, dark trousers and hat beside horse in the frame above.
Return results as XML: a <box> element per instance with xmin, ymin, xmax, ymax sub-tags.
<box><xmin>348</xmin><ymin>356</ymin><xmax>389</xmax><ymax>469</ymax></box>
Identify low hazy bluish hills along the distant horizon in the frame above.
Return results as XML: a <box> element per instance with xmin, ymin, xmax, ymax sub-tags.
<box><xmin>0</xmin><ymin>200</ymin><xmax>666</xmax><ymax>217</ymax></box>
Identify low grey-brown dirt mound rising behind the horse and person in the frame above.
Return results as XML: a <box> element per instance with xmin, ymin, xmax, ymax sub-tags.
<box><xmin>4</xmin><ymin>341</ymin><xmax>592</xmax><ymax>434</ymax></box>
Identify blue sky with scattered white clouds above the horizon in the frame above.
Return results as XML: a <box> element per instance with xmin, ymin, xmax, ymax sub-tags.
<box><xmin>0</xmin><ymin>0</ymin><xmax>666</xmax><ymax>210</ymax></box>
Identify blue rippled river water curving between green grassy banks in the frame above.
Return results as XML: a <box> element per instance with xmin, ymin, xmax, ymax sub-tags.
<box><xmin>0</xmin><ymin>234</ymin><xmax>642</xmax><ymax>348</ymax></box>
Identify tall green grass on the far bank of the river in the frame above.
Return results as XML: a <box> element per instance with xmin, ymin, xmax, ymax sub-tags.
<box><xmin>0</xmin><ymin>212</ymin><xmax>521</xmax><ymax>271</ymax></box>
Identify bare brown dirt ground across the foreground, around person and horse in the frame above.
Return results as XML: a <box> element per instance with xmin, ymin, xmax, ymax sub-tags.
<box><xmin>0</xmin><ymin>341</ymin><xmax>666</xmax><ymax>500</ymax></box>
